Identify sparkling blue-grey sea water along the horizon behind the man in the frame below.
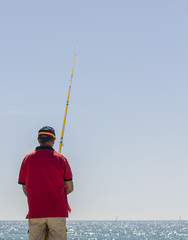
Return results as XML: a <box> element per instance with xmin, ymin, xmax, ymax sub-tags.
<box><xmin>0</xmin><ymin>221</ymin><xmax>188</xmax><ymax>240</ymax></box>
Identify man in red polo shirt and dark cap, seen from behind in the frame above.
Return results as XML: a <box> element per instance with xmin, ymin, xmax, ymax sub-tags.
<box><xmin>18</xmin><ymin>126</ymin><xmax>73</xmax><ymax>240</ymax></box>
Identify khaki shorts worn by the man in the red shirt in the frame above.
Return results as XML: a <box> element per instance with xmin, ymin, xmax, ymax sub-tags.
<box><xmin>29</xmin><ymin>218</ymin><xmax>67</xmax><ymax>240</ymax></box>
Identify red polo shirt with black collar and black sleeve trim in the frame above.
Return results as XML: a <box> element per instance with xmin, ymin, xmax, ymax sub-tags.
<box><xmin>18</xmin><ymin>146</ymin><xmax>72</xmax><ymax>218</ymax></box>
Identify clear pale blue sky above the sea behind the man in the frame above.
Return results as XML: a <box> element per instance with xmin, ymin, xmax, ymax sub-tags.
<box><xmin>0</xmin><ymin>0</ymin><xmax>188</xmax><ymax>220</ymax></box>
